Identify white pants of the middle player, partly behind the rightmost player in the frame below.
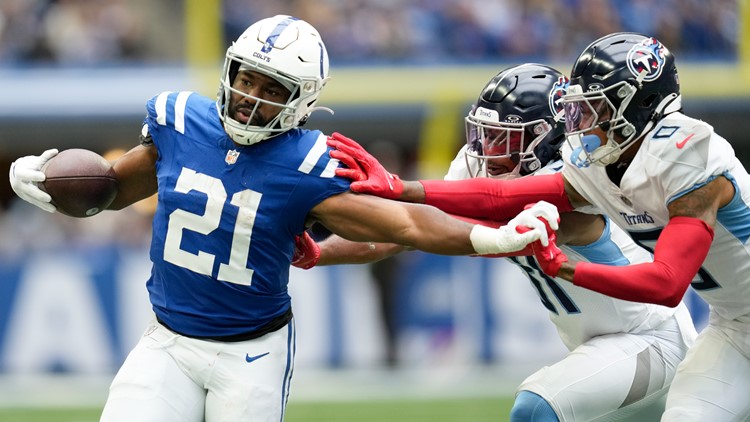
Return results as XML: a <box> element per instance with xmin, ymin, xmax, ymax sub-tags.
<box><xmin>518</xmin><ymin>306</ymin><xmax>697</xmax><ymax>422</ymax></box>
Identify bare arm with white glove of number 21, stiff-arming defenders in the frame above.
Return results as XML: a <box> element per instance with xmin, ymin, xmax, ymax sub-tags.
<box><xmin>310</xmin><ymin>193</ymin><xmax>559</xmax><ymax>255</ymax></box>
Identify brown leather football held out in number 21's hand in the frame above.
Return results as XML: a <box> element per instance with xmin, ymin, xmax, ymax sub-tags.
<box><xmin>39</xmin><ymin>148</ymin><xmax>117</xmax><ymax>218</ymax></box>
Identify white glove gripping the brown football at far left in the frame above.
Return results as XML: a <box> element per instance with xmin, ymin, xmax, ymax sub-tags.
<box><xmin>9</xmin><ymin>149</ymin><xmax>57</xmax><ymax>212</ymax></box>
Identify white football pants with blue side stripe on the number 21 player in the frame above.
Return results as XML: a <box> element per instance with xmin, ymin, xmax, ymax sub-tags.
<box><xmin>101</xmin><ymin>319</ymin><xmax>295</xmax><ymax>422</ymax></box>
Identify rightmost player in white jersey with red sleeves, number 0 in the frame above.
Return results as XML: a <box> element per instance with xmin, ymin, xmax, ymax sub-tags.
<box><xmin>332</xmin><ymin>33</ymin><xmax>750</xmax><ymax>421</ymax></box>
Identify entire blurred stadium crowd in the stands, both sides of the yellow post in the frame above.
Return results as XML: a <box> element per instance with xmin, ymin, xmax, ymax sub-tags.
<box><xmin>0</xmin><ymin>0</ymin><xmax>738</xmax><ymax>66</ymax></box>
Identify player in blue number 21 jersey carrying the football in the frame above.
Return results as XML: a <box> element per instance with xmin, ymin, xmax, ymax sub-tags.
<box><xmin>4</xmin><ymin>15</ymin><xmax>558</xmax><ymax>422</ymax></box>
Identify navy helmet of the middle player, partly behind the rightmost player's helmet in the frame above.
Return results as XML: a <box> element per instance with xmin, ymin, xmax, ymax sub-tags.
<box><xmin>465</xmin><ymin>63</ymin><xmax>568</xmax><ymax>178</ymax></box>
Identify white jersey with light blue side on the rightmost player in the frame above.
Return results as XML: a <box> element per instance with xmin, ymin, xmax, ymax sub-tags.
<box><xmin>562</xmin><ymin>113</ymin><xmax>750</xmax><ymax>324</ymax></box>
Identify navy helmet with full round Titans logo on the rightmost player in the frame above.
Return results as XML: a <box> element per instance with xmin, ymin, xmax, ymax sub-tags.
<box><xmin>562</xmin><ymin>32</ymin><xmax>682</xmax><ymax>167</ymax></box>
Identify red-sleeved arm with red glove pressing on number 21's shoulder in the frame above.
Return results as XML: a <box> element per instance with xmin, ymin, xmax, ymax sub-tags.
<box><xmin>328</xmin><ymin>133</ymin><xmax>581</xmax><ymax>221</ymax></box>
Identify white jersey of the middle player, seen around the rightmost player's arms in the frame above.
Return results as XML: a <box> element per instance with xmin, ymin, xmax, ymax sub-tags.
<box><xmin>445</xmin><ymin>146</ymin><xmax>685</xmax><ymax>350</ymax></box>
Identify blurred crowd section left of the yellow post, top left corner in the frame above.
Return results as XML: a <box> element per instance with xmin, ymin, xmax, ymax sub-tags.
<box><xmin>0</xmin><ymin>0</ymin><xmax>183</xmax><ymax>67</ymax></box>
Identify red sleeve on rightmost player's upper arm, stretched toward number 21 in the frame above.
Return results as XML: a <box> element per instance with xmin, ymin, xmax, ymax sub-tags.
<box><xmin>420</xmin><ymin>173</ymin><xmax>573</xmax><ymax>221</ymax></box>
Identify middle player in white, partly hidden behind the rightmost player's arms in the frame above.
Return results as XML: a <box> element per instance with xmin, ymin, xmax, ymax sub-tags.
<box><xmin>293</xmin><ymin>64</ymin><xmax>697</xmax><ymax>422</ymax></box>
